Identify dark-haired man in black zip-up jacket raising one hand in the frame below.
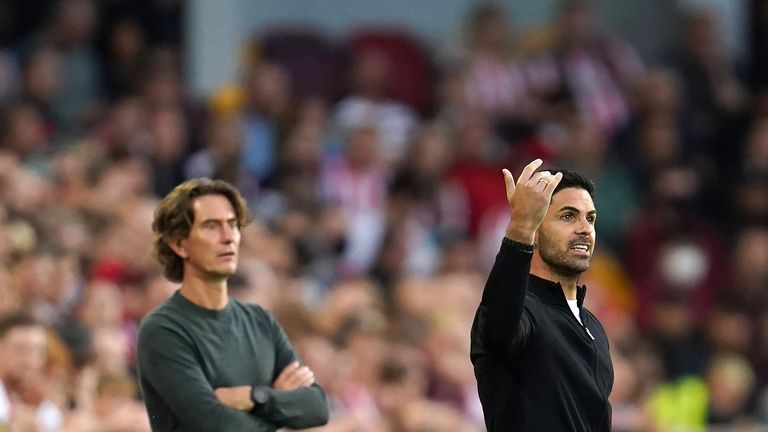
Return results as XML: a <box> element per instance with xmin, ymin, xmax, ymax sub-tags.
<box><xmin>471</xmin><ymin>159</ymin><xmax>613</xmax><ymax>432</ymax></box>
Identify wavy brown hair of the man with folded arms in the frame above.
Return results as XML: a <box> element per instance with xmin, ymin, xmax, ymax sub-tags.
<box><xmin>152</xmin><ymin>178</ymin><xmax>253</xmax><ymax>282</ymax></box>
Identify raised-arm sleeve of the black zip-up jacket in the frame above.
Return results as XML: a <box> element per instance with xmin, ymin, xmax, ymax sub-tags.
<box><xmin>472</xmin><ymin>238</ymin><xmax>535</xmax><ymax>354</ymax></box>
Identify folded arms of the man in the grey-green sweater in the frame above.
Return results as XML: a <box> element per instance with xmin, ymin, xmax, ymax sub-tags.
<box><xmin>138</xmin><ymin>318</ymin><xmax>328</xmax><ymax>432</ymax></box>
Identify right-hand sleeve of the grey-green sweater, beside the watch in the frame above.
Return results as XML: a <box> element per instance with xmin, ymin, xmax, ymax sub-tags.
<box><xmin>253</xmin><ymin>311</ymin><xmax>329</xmax><ymax>429</ymax></box>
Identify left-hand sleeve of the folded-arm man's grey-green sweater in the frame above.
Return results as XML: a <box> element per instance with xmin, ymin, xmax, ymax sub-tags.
<box><xmin>137</xmin><ymin>322</ymin><xmax>278</xmax><ymax>432</ymax></box>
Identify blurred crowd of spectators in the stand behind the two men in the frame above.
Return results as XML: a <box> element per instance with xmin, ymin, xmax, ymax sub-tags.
<box><xmin>0</xmin><ymin>0</ymin><xmax>768</xmax><ymax>432</ymax></box>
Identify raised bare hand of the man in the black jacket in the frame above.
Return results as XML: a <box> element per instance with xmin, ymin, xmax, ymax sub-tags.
<box><xmin>502</xmin><ymin>159</ymin><xmax>563</xmax><ymax>244</ymax></box>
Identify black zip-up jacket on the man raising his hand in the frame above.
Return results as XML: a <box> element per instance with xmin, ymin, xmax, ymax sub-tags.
<box><xmin>471</xmin><ymin>241</ymin><xmax>613</xmax><ymax>432</ymax></box>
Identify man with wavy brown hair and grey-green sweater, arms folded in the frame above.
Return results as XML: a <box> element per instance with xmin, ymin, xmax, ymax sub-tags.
<box><xmin>137</xmin><ymin>179</ymin><xmax>328</xmax><ymax>432</ymax></box>
